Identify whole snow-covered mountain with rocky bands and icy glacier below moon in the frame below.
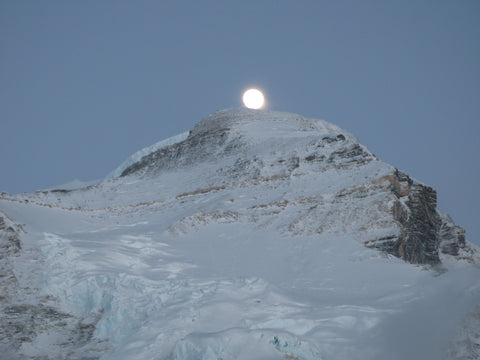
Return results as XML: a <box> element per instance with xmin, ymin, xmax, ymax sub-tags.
<box><xmin>0</xmin><ymin>109</ymin><xmax>480</xmax><ymax>359</ymax></box>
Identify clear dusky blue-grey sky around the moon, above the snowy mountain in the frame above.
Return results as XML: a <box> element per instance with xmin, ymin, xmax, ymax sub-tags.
<box><xmin>0</xmin><ymin>0</ymin><xmax>480</xmax><ymax>244</ymax></box>
